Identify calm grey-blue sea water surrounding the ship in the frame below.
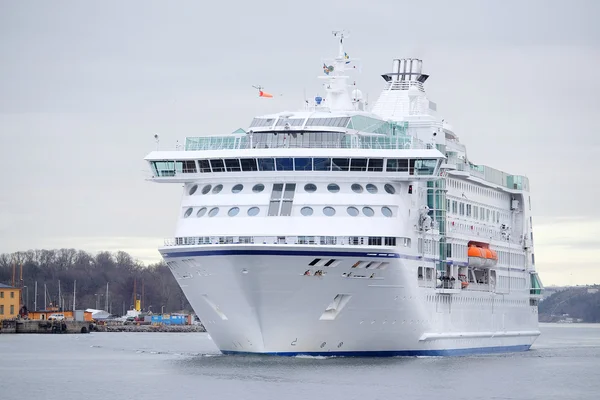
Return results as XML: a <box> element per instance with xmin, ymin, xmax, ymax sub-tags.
<box><xmin>0</xmin><ymin>324</ymin><xmax>600</xmax><ymax>400</ymax></box>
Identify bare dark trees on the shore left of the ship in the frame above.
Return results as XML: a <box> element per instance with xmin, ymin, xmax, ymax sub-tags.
<box><xmin>0</xmin><ymin>249</ymin><xmax>192</xmax><ymax>315</ymax></box>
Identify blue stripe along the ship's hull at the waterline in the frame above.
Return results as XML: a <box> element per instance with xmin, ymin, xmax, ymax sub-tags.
<box><xmin>221</xmin><ymin>344</ymin><xmax>531</xmax><ymax>357</ymax></box>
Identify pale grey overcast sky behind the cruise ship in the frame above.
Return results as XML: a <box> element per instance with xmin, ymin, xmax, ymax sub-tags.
<box><xmin>0</xmin><ymin>0</ymin><xmax>600</xmax><ymax>285</ymax></box>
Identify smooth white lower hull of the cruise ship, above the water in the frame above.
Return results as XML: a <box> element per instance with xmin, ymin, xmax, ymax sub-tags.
<box><xmin>161</xmin><ymin>245</ymin><xmax>539</xmax><ymax>356</ymax></box>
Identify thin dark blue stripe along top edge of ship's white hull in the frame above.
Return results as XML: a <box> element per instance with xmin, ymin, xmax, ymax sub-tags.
<box><xmin>163</xmin><ymin>249</ymin><xmax>525</xmax><ymax>271</ymax></box>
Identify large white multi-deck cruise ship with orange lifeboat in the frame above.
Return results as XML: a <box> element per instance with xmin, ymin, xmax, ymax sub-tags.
<box><xmin>145</xmin><ymin>32</ymin><xmax>543</xmax><ymax>356</ymax></box>
